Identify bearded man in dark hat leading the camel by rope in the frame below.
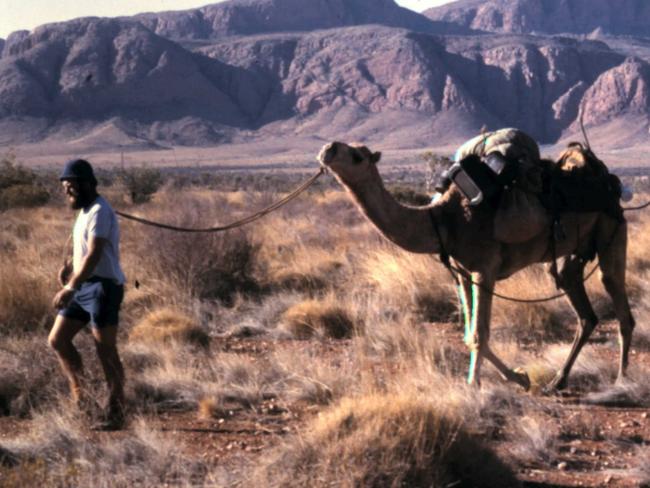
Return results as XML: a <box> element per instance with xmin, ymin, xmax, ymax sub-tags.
<box><xmin>48</xmin><ymin>159</ymin><xmax>125</xmax><ymax>430</ymax></box>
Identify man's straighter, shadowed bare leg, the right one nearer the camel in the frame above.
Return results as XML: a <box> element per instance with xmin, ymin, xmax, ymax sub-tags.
<box><xmin>91</xmin><ymin>325</ymin><xmax>124</xmax><ymax>416</ymax></box>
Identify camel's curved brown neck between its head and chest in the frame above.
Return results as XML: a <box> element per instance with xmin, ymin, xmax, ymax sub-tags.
<box><xmin>339</xmin><ymin>173</ymin><xmax>446</xmax><ymax>253</ymax></box>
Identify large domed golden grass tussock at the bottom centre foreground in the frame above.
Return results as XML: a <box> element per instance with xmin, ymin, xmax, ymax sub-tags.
<box><xmin>255</xmin><ymin>394</ymin><xmax>518</xmax><ymax>487</ymax></box>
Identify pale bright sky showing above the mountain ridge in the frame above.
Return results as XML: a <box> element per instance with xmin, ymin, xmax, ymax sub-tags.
<box><xmin>0</xmin><ymin>0</ymin><xmax>451</xmax><ymax>39</ymax></box>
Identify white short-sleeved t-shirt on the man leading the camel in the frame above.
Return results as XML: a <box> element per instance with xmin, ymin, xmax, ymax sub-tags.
<box><xmin>72</xmin><ymin>196</ymin><xmax>126</xmax><ymax>285</ymax></box>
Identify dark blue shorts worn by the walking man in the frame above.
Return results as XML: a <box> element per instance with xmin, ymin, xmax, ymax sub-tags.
<box><xmin>59</xmin><ymin>276</ymin><xmax>124</xmax><ymax>328</ymax></box>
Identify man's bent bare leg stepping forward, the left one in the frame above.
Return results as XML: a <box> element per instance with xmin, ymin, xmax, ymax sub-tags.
<box><xmin>47</xmin><ymin>315</ymin><xmax>86</xmax><ymax>405</ymax></box>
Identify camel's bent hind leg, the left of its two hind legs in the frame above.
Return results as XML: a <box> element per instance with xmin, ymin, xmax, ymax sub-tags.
<box><xmin>547</xmin><ymin>256</ymin><xmax>598</xmax><ymax>390</ymax></box>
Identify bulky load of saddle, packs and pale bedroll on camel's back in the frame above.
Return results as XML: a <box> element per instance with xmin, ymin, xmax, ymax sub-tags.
<box><xmin>437</xmin><ymin>129</ymin><xmax>623</xmax><ymax>244</ymax></box>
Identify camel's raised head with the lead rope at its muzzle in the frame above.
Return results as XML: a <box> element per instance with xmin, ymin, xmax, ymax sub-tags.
<box><xmin>318</xmin><ymin>141</ymin><xmax>381</xmax><ymax>183</ymax></box>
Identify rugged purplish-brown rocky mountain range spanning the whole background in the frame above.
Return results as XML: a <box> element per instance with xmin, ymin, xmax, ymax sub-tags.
<box><xmin>0</xmin><ymin>0</ymin><xmax>650</xmax><ymax>154</ymax></box>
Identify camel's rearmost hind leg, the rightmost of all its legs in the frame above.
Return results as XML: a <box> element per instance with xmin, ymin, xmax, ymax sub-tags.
<box><xmin>597</xmin><ymin>219</ymin><xmax>635</xmax><ymax>381</ymax></box>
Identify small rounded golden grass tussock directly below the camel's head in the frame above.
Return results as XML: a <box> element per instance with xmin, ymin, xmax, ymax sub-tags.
<box><xmin>279</xmin><ymin>297</ymin><xmax>358</xmax><ymax>339</ymax></box>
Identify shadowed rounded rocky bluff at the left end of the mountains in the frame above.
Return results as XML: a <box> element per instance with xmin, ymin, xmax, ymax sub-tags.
<box><xmin>0</xmin><ymin>18</ymin><xmax>246</xmax><ymax>143</ymax></box>
